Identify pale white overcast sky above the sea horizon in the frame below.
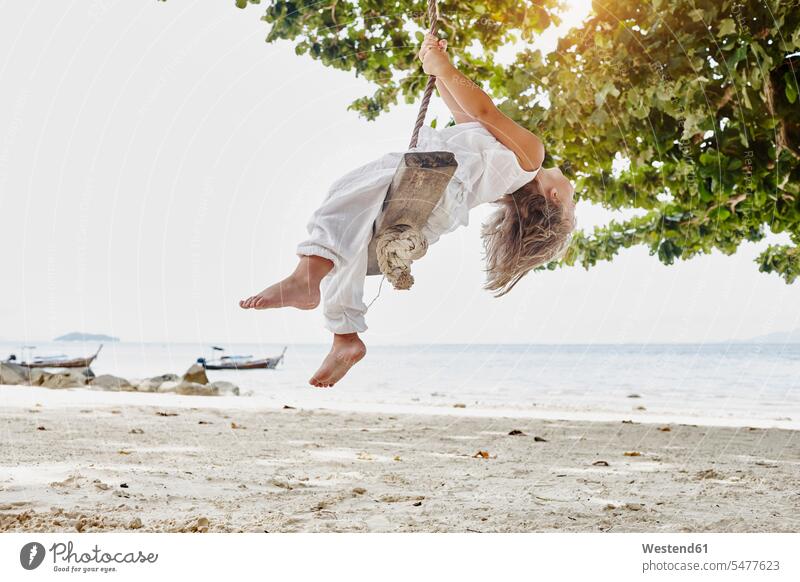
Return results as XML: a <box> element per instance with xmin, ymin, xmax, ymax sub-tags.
<box><xmin>0</xmin><ymin>0</ymin><xmax>800</xmax><ymax>343</ymax></box>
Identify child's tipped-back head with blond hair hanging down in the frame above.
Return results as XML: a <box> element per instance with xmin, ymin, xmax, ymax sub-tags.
<box><xmin>482</xmin><ymin>180</ymin><xmax>575</xmax><ymax>297</ymax></box>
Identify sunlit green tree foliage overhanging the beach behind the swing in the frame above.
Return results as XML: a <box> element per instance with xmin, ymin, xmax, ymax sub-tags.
<box><xmin>237</xmin><ymin>0</ymin><xmax>800</xmax><ymax>283</ymax></box>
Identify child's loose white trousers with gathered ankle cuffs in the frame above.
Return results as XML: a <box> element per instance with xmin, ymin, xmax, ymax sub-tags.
<box><xmin>297</xmin><ymin>153</ymin><xmax>403</xmax><ymax>333</ymax></box>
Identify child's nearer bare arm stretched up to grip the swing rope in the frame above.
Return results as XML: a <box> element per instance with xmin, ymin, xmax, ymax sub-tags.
<box><xmin>419</xmin><ymin>35</ymin><xmax>544</xmax><ymax>171</ymax></box>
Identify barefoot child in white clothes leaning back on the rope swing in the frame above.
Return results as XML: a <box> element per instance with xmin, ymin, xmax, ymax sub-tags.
<box><xmin>239</xmin><ymin>34</ymin><xmax>575</xmax><ymax>387</ymax></box>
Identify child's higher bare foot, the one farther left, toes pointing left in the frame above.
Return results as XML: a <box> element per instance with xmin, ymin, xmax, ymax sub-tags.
<box><xmin>239</xmin><ymin>256</ymin><xmax>333</xmax><ymax>309</ymax></box>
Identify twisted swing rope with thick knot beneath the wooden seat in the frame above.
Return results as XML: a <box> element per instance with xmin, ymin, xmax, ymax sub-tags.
<box><xmin>375</xmin><ymin>0</ymin><xmax>439</xmax><ymax>289</ymax></box>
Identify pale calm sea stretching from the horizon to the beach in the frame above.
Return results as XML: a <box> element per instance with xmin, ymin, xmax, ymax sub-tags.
<box><xmin>0</xmin><ymin>342</ymin><xmax>800</xmax><ymax>428</ymax></box>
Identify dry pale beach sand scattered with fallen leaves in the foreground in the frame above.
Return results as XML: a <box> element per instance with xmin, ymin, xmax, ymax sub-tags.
<box><xmin>0</xmin><ymin>402</ymin><xmax>800</xmax><ymax>532</ymax></box>
